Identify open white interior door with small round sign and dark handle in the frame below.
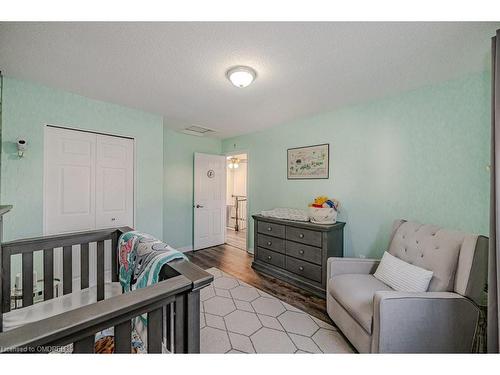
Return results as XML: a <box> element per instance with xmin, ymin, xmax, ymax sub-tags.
<box><xmin>193</xmin><ymin>153</ymin><xmax>226</xmax><ymax>250</ymax></box>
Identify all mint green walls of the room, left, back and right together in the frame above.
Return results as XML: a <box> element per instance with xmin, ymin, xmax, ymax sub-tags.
<box><xmin>1</xmin><ymin>73</ymin><xmax>490</xmax><ymax>262</ymax></box>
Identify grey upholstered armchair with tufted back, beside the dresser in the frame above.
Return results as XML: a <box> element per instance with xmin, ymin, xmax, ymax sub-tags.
<box><xmin>327</xmin><ymin>220</ymin><xmax>488</xmax><ymax>353</ymax></box>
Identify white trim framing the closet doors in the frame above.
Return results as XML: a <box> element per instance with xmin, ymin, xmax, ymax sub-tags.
<box><xmin>42</xmin><ymin>124</ymin><xmax>137</xmax><ymax>236</ymax></box>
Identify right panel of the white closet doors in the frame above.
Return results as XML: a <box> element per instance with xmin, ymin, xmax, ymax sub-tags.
<box><xmin>96</xmin><ymin>135</ymin><xmax>134</xmax><ymax>229</ymax></box>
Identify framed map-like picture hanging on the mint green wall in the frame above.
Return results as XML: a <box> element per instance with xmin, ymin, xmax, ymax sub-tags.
<box><xmin>287</xmin><ymin>143</ymin><xmax>330</xmax><ymax>180</ymax></box>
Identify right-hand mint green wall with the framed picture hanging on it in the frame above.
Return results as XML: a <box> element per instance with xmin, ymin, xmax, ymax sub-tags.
<box><xmin>223</xmin><ymin>73</ymin><xmax>490</xmax><ymax>257</ymax></box>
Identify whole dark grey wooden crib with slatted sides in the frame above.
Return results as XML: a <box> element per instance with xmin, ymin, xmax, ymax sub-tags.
<box><xmin>0</xmin><ymin>206</ymin><xmax>213</xmax><ymax>353</ymax></box>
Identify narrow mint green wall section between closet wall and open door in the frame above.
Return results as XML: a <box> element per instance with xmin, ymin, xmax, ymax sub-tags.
<box><xmin>163</xmin><ymin>127</ymin><xmax>222</xmax><ymax>249</ymax></box>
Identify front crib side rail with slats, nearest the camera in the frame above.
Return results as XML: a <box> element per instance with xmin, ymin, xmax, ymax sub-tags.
<box><xmin>0</xmin><ymin>275</ymin><xmax>192</xmax><ymax>353</ymax></box>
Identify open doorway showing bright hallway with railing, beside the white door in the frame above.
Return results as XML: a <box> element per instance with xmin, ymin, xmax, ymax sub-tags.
<box><xmin>226</xmin><ymin>153</ymin><xmax>248</xmax><ymax>251</ymax></box>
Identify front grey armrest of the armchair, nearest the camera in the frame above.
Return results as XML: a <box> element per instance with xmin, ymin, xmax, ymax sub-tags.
<box><xmin>372</xmin><ymin>291</ymin><xmax>479</xmax><ymax>353</ymax></box>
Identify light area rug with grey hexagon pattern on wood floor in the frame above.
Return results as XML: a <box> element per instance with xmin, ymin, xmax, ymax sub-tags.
<box><xmin>200</xmin><ymin>268</ymin><xmax>353</xmax><ymax>353</ymax></box>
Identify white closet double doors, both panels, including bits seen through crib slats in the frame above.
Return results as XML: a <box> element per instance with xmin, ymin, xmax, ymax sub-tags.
<box><xmin>44</xmin><ymin>127</ymin><xmax>134</xmax><ymax>290</ymax></box>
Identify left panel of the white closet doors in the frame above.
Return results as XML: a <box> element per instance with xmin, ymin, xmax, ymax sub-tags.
<box><xmin>44</xmin><ymin>127</ymin><xmax>96</xmax><ymax>234</ymax></box>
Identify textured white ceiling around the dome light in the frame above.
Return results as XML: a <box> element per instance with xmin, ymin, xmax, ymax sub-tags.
<box><xmin>0</xmin><ymin>22</ymin><xmax>500</xmax><ymax>138</ymax></box>
